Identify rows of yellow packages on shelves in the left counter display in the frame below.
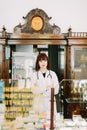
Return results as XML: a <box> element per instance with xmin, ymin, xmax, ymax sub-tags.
<box><xmin>4</xmin><ymin>86</ymin><xmax>33</xmax><ymax>121</ymax></box>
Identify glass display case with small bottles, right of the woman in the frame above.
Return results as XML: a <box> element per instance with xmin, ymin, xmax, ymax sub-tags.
<box><xmin>60</xmin><ymin>79</ymin><xmax>87</xmax><ymax>118</ymax></box>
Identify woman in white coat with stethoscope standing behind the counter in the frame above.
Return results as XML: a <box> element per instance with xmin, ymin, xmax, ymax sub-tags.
<box><xmin>31</xmin><ymin>53</ymin><xmax>59</xmax><ymax>119</ymax></box>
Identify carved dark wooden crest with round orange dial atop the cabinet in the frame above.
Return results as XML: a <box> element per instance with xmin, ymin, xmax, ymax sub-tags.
<box><xmin>14</xmin><ymin>8</ymin><xmax>61</xmax><ymax>34</ymax></box>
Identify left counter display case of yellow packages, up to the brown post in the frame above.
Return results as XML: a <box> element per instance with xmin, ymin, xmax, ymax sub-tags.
<box><xmin>0</xmin><ymin>79</ymin><xmax>55</xmax><ymax>130</ymax></box>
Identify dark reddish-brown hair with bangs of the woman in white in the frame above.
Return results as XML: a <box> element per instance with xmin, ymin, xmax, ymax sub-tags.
<box><xmin>35</xmin><ymin>53</ymin><xmax>50</xmax><ymax>71</ymax></box>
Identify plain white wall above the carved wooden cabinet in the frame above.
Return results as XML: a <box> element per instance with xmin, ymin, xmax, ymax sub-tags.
<box><xmin>0</xmin><ymin>0</ymin><xmax>87</xmax><ymax>33</ymax></box>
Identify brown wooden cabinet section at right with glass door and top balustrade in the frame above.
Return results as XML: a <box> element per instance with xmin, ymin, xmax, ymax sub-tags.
<box><xmin>67</xmin><ymin>32</ymin><xmax>87</xmax><ymax>79</ymax></box>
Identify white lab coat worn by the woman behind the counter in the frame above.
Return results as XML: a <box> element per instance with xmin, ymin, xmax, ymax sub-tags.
<box><xmin>31</xmin><ymin>70</ymin><xmax>59</xmax><ymax>118</ymax></box>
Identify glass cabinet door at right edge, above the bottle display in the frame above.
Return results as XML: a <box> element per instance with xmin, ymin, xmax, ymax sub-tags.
<box><xmin>71</xmin><ymin>46</ymin><xmax>87</xmax><ymax>79</ymax></box>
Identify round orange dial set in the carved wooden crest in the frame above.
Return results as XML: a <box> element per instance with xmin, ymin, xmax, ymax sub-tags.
<box><xmin>31</xmin><ymin>16</ymin><xmax>43</xmax><ymax>31</ymax></box>
